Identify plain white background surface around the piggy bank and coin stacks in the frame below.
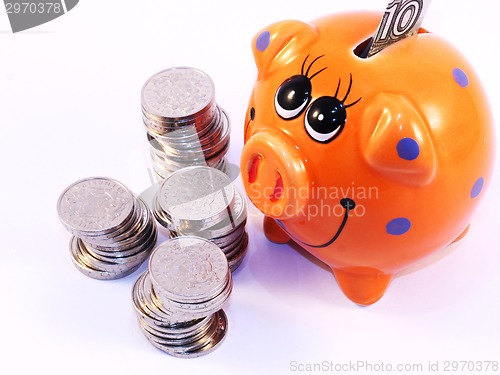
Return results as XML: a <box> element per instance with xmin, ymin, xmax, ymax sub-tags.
<box><xmin>0</xmin><ymin>0</ymin><xmax>500</xmax><ymax>374</ymax></box>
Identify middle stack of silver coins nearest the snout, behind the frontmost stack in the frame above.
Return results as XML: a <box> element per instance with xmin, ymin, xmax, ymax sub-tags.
<box><xmin>153</xmin><ymin>166</ymin><xmax>248</xmax><ymax>271</ymax></box>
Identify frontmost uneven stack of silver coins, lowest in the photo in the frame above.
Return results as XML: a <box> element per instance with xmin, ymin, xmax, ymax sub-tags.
<box><xmin>132</xmin><ymin>236</ymin><xmax>233</xmax><ymax>358</ymax></box>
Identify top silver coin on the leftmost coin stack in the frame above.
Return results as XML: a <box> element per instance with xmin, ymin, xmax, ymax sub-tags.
<box><xmin>57</xmin><ymin>177</ymin><xmax>134</xmax><ymax>235</ymax></box>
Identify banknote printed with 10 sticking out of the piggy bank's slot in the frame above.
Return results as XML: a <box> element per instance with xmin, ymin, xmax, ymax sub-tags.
<box><xmin>365</xmin><ymin>0</ymin><xmax>431</xmax><ymax>57</ymax></box>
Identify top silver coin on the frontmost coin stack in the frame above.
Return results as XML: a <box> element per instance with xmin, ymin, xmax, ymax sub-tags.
<box><xmin>149</xmin><ymin>236</ymin><xmax>229</xmax><ymax>302</ymax></box>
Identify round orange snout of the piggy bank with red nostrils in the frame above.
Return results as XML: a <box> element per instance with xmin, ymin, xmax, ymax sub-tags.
<box><xmin>241</xmin><ymin>131</ymin><xmax>309</xmax><ymax>220</ymax></box>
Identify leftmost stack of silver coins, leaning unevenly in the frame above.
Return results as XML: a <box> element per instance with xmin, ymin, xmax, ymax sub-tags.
<box><xmin>57</xmin><ymin>177</ymin><xmax>158</xmax><ymax>280</ymax></box>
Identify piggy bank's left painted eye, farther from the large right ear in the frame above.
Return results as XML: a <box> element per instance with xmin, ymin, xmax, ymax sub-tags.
<box><xmin>274</xmin><ymin>75</ymin><xmax>311</xmax><ymax>120</ymax></box>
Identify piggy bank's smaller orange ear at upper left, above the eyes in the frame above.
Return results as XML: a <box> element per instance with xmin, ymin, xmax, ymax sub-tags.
<box><xmin>252</xmin><ymin>20</ymin><xmax>317</xmax><ymax>76</ymax></box>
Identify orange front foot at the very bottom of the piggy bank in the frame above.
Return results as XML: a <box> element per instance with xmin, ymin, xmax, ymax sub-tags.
<box><xmin>333</xmin><ymin>267</ymin><xmax>392</xmax><ymax>305</ymax></box>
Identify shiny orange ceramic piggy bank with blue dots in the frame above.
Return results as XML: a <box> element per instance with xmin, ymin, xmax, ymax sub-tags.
<box><xmin>240</xmin><ymin>12</ymin><xmax>494</xmax><ymax>305</ymax></box>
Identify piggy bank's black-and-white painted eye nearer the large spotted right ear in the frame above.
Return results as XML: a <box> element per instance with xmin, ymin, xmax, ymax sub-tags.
<box><xmin>305</xmin><ymin>96</ymin><xmax>346</xmax><ymax>143</ymax></box>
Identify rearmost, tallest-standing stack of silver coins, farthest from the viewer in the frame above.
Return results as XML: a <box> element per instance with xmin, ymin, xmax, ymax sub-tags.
<box><xmin>141</xmin><ymin>67</ymin><xmax>230</xmax><ymax>180</ymax></box>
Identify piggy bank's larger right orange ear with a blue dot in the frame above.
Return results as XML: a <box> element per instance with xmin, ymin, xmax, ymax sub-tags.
<box><xmin>359</xmin><ymin>92</ymin><xmax>437</xmax><ymax>186</ymax></box>
